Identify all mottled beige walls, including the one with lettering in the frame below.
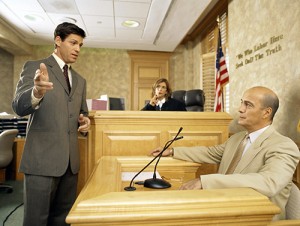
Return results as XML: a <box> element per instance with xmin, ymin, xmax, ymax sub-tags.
<box><xmin>0</xmin><ymin>0</ymin><xmax>300</xmax><ymax>142</ymax></box>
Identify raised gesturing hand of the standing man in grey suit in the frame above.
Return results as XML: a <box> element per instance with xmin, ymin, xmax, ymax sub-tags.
<box><xmin>33</xmin><ymin>63</ymin><xmax>53</xmax><ymax>98</ymax></box>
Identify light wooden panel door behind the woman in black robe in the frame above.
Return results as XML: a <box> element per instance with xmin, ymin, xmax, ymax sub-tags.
<box><xmin>128</xmin><ymin>51</ymin><xmax>171</xmax><ymax>110</ymax></box>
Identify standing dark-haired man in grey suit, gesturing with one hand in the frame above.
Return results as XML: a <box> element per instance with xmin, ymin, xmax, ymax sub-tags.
<box><xmin>12</xmin><ymin>23</ymin><xmax>90</xmax><ymax>226</ymax></box>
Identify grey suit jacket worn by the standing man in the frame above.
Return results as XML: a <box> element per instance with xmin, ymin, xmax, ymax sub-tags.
<box><xmin>12</xmin><ymin>56</ymin><xmax>88</xmax><ymax>176</ymax></box>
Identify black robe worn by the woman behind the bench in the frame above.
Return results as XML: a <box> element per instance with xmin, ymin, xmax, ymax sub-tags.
<box><xmin>142</xmin><ymin>97</ymin><xmax>186</xmax><ymax>111</ymax></box>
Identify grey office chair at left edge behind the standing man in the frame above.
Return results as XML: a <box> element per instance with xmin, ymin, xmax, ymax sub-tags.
<box><xmin>0</xmin><ymin>129</ymin><xmax>19</xmax><ymax>193</ymax></box>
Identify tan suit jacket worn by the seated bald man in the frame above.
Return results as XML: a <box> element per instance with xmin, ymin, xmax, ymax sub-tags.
<box><xmin>174</xmin><ymin>125</ymin><xmax>300</xmax><ymax>219</ymax></box>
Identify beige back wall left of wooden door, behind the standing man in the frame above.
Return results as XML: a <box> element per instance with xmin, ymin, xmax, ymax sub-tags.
<box><xmin>14</xmin><ymin>46</ymin><xmax>131</xmax><ymax>109</ymax></box>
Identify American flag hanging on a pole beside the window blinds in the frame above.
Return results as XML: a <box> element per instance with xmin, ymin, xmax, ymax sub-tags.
<box><xmin>214</xmin><ymin>30</ymin><xmax>229</xmax><ymax>112</ymax></box>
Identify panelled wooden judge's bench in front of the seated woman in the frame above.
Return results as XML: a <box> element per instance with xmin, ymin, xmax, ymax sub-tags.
<box><xmin>85</xmin><ymin>111</ymin><xmax>232</xmax><ymax>178</ymax></box>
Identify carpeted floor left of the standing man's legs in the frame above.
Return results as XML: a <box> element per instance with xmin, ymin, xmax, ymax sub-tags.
<box><xmin>0</xmin><ymin>181</ymin><xmax>23</xmax><ymax>226</ymax></box>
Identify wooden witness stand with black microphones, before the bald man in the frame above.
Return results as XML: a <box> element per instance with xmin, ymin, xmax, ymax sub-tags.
<box><xmin>66</xmin><ymin>156</ymin><xmax>280</xmax><ymax>226</ymax></box>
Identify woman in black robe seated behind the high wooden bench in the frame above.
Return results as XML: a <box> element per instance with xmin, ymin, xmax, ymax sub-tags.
<box><xmin>142</xmin><ymin>78</ymin><xmax>186</xmax><ymax>111</ymax></box>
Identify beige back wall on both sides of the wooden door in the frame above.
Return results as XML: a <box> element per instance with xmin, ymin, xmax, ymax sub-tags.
<box><xmin>11</xmin><ymin>43</ymin><xmax>200</xmax><ymax>110</ymax></box>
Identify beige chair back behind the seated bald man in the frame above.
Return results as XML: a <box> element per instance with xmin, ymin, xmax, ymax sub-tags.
<box><xmin>285</xmin><ymin>183</ymin><xmax>300</xmax><ymax>220</ymax></box>
